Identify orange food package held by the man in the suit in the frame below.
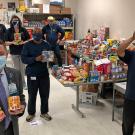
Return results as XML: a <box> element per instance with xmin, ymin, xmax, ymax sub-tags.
<box><xmin>8</xmin><ymin>96</ymin><xmax>21</xmax><ymax>111</ymax></box>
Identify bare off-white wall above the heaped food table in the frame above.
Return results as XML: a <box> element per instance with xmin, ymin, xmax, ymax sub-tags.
<box><xmin>76</xmin><ymin>0</ymin><xmax>135</xmax><ymax>39</ymax></box>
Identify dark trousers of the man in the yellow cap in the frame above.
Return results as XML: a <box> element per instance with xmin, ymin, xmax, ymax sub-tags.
<box><xmin>52</xmin><ymin>44</ymin><xmax>62</xmax><ymax>67</ymax></box>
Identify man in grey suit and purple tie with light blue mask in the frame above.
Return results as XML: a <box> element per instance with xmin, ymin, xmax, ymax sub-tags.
<box><xmin>0</xmin><ymin>41</ymin><xmax>26</xmax><ymax>135</ymax></box>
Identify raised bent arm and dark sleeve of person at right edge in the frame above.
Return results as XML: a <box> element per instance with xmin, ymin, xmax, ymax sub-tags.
<box><xmin>117</xmin><ymin>32</ymin><xmax>135</xmax><ymax>64</ymax></box>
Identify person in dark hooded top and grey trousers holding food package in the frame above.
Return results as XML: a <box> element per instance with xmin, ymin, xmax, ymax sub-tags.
<box><xmin>6</xmin><ymin>15</ymin><xmax>30</xmax><ymax>88</ymax></box>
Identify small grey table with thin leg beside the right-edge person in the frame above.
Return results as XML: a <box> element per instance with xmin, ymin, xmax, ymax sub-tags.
<box><xmin>112</xmin><ymin>82</ymin><xmax>127</xmax><ymax>121</ymax></box>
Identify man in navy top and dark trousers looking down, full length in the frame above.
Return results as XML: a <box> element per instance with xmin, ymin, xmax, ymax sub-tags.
<box><xmin>22</xmin><ymin>28</ymin><xmax>52</xmax><ymax>122</ymax></box>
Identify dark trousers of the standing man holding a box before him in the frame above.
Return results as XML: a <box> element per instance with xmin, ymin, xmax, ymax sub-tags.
<box><xmin>27</xmin><ymin>75</ymin><xmax>50</xmax><ymax>115</ymax></box>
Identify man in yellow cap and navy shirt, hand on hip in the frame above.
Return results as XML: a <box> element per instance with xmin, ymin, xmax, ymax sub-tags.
<box><xmin>42</xmin><ymin>16</ymin><xmax>65</xmax><ymax>66</ymax></box>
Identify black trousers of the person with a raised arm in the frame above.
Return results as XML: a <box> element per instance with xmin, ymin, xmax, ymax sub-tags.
<box><xmin>122</xmin><ymin>99</ymin><xmax>135</xmax><ymax>135</ymax></box>
